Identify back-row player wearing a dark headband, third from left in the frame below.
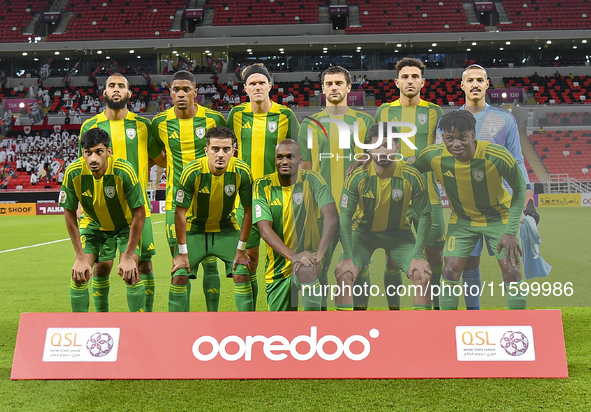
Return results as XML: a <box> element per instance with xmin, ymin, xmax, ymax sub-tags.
<box><xmin>228</xmin><ymin>63</ymin><xmax>300</xmax><ymax>308</ymax></box>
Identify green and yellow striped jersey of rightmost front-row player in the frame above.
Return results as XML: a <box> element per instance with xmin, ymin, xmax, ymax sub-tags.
<box><xmin>415</xmin><ymin>140</ymin><xmax>526</xmax><ymax>235</ymax></box>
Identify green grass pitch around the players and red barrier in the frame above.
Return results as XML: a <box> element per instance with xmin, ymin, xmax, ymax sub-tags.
<box><xmin>0</xmin><ymin>208</ymin><xmax>591</xmax><ymax>411</ymax></box>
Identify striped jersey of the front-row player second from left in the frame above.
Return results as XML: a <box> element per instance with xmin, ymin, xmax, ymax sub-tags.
<box><xmin>174</xmin><ymin>157</ymin><xmax>252</xmax><ymax>232</ymax></box>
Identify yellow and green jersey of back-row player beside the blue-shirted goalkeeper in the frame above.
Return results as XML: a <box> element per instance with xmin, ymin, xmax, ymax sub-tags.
<box><xmin>376</xmin><ymin>99</ymin><xmax>443</xmax><ymax>205</ymax></box>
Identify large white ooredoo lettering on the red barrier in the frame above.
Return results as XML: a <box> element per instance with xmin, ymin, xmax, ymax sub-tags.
<box><xmin>193</xmin><ymin>326</ymin><xmax>380</xmax><ymax>362</ymax></box>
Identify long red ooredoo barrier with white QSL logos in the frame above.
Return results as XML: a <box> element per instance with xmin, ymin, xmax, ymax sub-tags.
<box><xmin>11</xmin><ymin>310</ymin><xmax>568</xmax><ymax>379</ymax></box>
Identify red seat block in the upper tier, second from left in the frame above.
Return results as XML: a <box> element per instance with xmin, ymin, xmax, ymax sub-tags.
<box><xmin>47</xmin><ymin>0</ymin><xmax>187</xmax><ymax>41</ymax></box>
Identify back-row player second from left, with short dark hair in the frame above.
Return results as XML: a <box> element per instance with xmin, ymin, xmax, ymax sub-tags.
<box><xmin>152</xmin><ymin>70</ymin><xmax>226</xmax><ymax>311</ymax></box>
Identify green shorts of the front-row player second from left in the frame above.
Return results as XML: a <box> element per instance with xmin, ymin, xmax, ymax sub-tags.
<box><xmin>173</xmin><ymin>230</ymin><xmax>248</xmax><ymax>279</ymax></box>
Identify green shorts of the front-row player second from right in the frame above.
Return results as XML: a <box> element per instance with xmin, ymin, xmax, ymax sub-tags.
<box><xmin>340</xmin><ymin>230</ymin><xmax>415</xmax><ymax>273</ymax></box>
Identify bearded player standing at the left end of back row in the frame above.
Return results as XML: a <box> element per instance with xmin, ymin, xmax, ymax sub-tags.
<box><xmin>79</xmin><ymin>73</ymin><xmax>166</xmax><ymax>312</ymax></box>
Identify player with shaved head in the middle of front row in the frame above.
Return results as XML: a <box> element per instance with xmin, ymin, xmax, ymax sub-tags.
<box><xmin>253</xmin><ymin>139</ymin><xmax>338</xmax><ymax>311</ymax></box>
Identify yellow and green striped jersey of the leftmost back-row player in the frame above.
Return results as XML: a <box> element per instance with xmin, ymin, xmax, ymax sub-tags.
<box><xmin>78</xmin><ymin>111</ymin><xmax>161</xmax><ymax>217</ymax></box>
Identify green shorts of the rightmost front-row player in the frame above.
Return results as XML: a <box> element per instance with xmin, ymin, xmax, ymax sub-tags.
<box><xmin>443</xmin><ymin>219</ymin><xmax>521</xmax><ymax>259</ymax></box>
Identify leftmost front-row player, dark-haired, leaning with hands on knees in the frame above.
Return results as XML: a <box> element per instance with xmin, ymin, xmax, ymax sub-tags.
<box><xmin>59</xmin><ymin>128</ymin><xmax>146</xmax><ymax>312</ymax></box>
